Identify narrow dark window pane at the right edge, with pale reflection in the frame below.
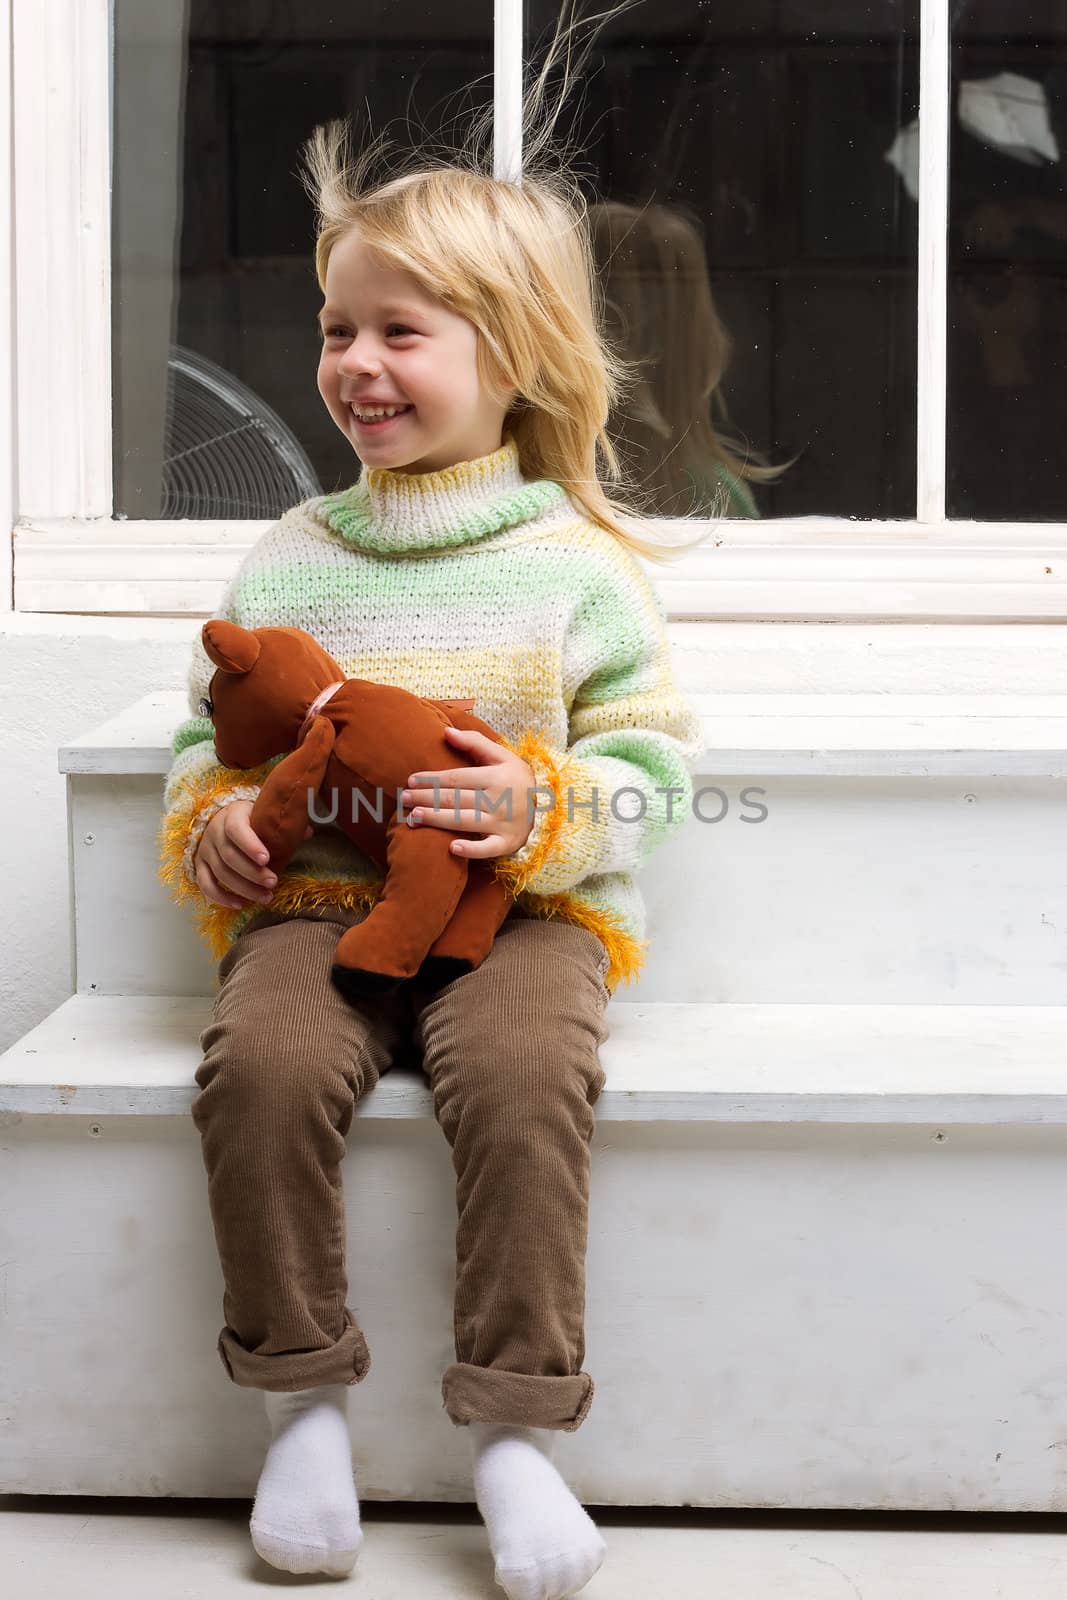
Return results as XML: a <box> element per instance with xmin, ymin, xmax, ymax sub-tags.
<box><xmin>947</xmin><ymin>0</ymin><xmax>1067</xmax><ymax>522</ymax></box>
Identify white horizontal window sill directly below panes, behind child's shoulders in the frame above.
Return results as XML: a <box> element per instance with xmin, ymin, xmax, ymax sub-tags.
<box><xmin>14</xmin><ymin>518</ymin><xmax>1067</xmax><ymax>622</ymax></box>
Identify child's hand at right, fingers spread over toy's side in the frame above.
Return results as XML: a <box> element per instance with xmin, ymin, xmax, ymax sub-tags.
<box><xmin>402</xmin><ymin>728</ymin><xmax>537</xmax><ymax>861</ymax></box>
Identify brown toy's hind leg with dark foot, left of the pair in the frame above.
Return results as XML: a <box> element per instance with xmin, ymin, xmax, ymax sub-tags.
<box><xmin>330</xmin><ymin>818</ymin><xmax>469</xmax><ymax>1000</ymax></box>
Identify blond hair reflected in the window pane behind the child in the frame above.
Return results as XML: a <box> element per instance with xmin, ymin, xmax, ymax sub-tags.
<box><xmin>590</xmin><ymin>200</ymin><xmax>784</xmax><ymax>517</ymax></box>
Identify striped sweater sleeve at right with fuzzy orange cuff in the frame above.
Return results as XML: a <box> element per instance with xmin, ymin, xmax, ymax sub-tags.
<box><xmin>498</xmin><ymin>552</ymin><xmax>704</xmax><ymax>894</ymax></box>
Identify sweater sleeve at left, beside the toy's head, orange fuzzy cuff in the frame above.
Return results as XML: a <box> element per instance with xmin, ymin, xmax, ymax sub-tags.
<box><xmin>158</xmin><ymin>571</ymin><xmax>282</xmax><ymax>906</ymax></box>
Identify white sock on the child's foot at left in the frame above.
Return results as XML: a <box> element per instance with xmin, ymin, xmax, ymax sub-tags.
<box><xmin>250</xmin><ymin>1384</ymin><xmax>363</xmax><ymax>1578</ymax></box>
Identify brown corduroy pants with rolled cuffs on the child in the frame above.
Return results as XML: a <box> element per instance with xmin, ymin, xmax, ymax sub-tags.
<box><xmin>192</xmin><ymin>910</ymin><xmax>608</xmax><ymax>1432</ymax></box>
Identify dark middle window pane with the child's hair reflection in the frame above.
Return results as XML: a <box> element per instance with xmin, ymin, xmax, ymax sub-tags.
<box><xmin>526</xmin><ymin>0</ymin><xmax>918</xmax><ymax>518</ymax></box>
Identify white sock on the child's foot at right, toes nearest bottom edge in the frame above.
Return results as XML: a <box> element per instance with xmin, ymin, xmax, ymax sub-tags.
<box><xmin>467</xmin><ymin>1422</ymin><xmax>606</xmax><ymax>1600</ymax></box>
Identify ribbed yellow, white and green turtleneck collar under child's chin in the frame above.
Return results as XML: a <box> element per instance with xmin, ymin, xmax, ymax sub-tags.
<box><xmin>317</xmin><ymin>435</ymin><xmax>566</xmax><ymax>555</ymax></box>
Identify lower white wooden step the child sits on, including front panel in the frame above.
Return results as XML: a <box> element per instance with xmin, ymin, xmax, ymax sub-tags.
<box><xmin>0</xmin><ymin>995</ymin><xmax>1067</xmax><ymax>1514</ymax></box>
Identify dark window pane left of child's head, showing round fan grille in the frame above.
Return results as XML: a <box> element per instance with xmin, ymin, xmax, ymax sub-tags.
<box><xmin>114</xmin><ymin>0</ymin><xmax>493</xmax><ymax>518</ymax></box>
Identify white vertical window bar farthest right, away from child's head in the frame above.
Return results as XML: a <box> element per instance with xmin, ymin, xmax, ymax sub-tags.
<box><xmin>915</xmin><ymin>0</ymin><xmax>950</xmax><ymax>525</ymax></box>
